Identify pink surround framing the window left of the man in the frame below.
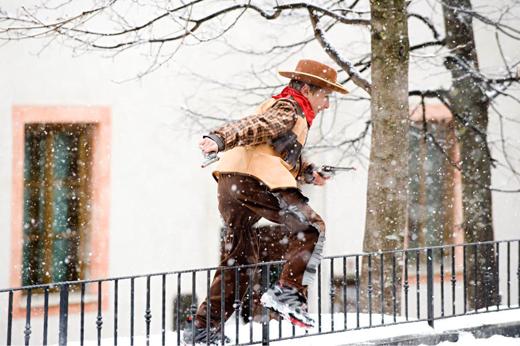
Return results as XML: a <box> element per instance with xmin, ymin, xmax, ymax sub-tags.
<box><xmin>9</xmin><ymin>105</ymin><xmax>112</xmax><ymax>318</ymax></box>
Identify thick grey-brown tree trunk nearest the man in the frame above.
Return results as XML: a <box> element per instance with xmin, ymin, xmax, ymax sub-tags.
<box><xmin>362</xmin><ymin>0</ymin><xmax>409</xmax><ymax>313</ymax></box>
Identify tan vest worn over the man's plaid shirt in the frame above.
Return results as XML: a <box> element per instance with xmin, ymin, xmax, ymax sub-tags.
<box><xmin>213</xmin><ymin>99</ymin><xmax>308</xmax><ymax>189</ymax></box>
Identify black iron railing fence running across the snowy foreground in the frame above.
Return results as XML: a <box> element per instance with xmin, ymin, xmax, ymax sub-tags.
<box><xmin>0</xmin><ymin>240</ymin><xmax>520</xmax><ymax>345</ymax></box>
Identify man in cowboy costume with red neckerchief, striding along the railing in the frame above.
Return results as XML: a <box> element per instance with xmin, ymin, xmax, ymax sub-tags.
<box><xmin>184</xmin><ymin>60</ymin><xmax>347</xmax><ymax>342</ymax></box>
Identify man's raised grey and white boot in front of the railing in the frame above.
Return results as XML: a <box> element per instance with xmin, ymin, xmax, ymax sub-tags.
<box><xmin>260</xmin><ymin>284</ymin><xmax>314</xmax><ymax>329</ymax></box>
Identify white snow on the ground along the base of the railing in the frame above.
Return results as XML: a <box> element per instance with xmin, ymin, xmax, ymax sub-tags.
<box><xmin>61</xmin><ymin>309</ymin><xmax>520</xmax><ymax>346</ymax></box>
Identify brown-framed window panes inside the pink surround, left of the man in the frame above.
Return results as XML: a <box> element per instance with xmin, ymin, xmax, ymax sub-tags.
<box><xmin>22</xmin><ymin>123</ymin><xmax>94</xmax><ymax>285</ymax></box>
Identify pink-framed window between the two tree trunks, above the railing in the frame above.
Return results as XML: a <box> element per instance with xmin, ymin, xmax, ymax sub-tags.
<box><xmin>408</xmin><ymin>105</ymin><xmax>462</xmax><ymax>248</ymax></box>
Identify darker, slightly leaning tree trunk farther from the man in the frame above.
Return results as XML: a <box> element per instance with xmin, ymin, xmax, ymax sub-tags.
<box><xmin>443</xmin><ymin>0</ymin><xmax>497</xmax><ymax>308</ymax></box>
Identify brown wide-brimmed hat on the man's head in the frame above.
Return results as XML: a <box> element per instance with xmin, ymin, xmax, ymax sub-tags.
<box><xmin>278</xmin><ymin>60</ymin><xmax>348</xmax><ymax>94</ymax></box>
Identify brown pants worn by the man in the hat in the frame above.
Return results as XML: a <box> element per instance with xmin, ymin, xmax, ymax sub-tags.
<box><xmin>196</xmin><ymin>174</ymin><xmax>325</xmax><ymax>327</ymax></box>
